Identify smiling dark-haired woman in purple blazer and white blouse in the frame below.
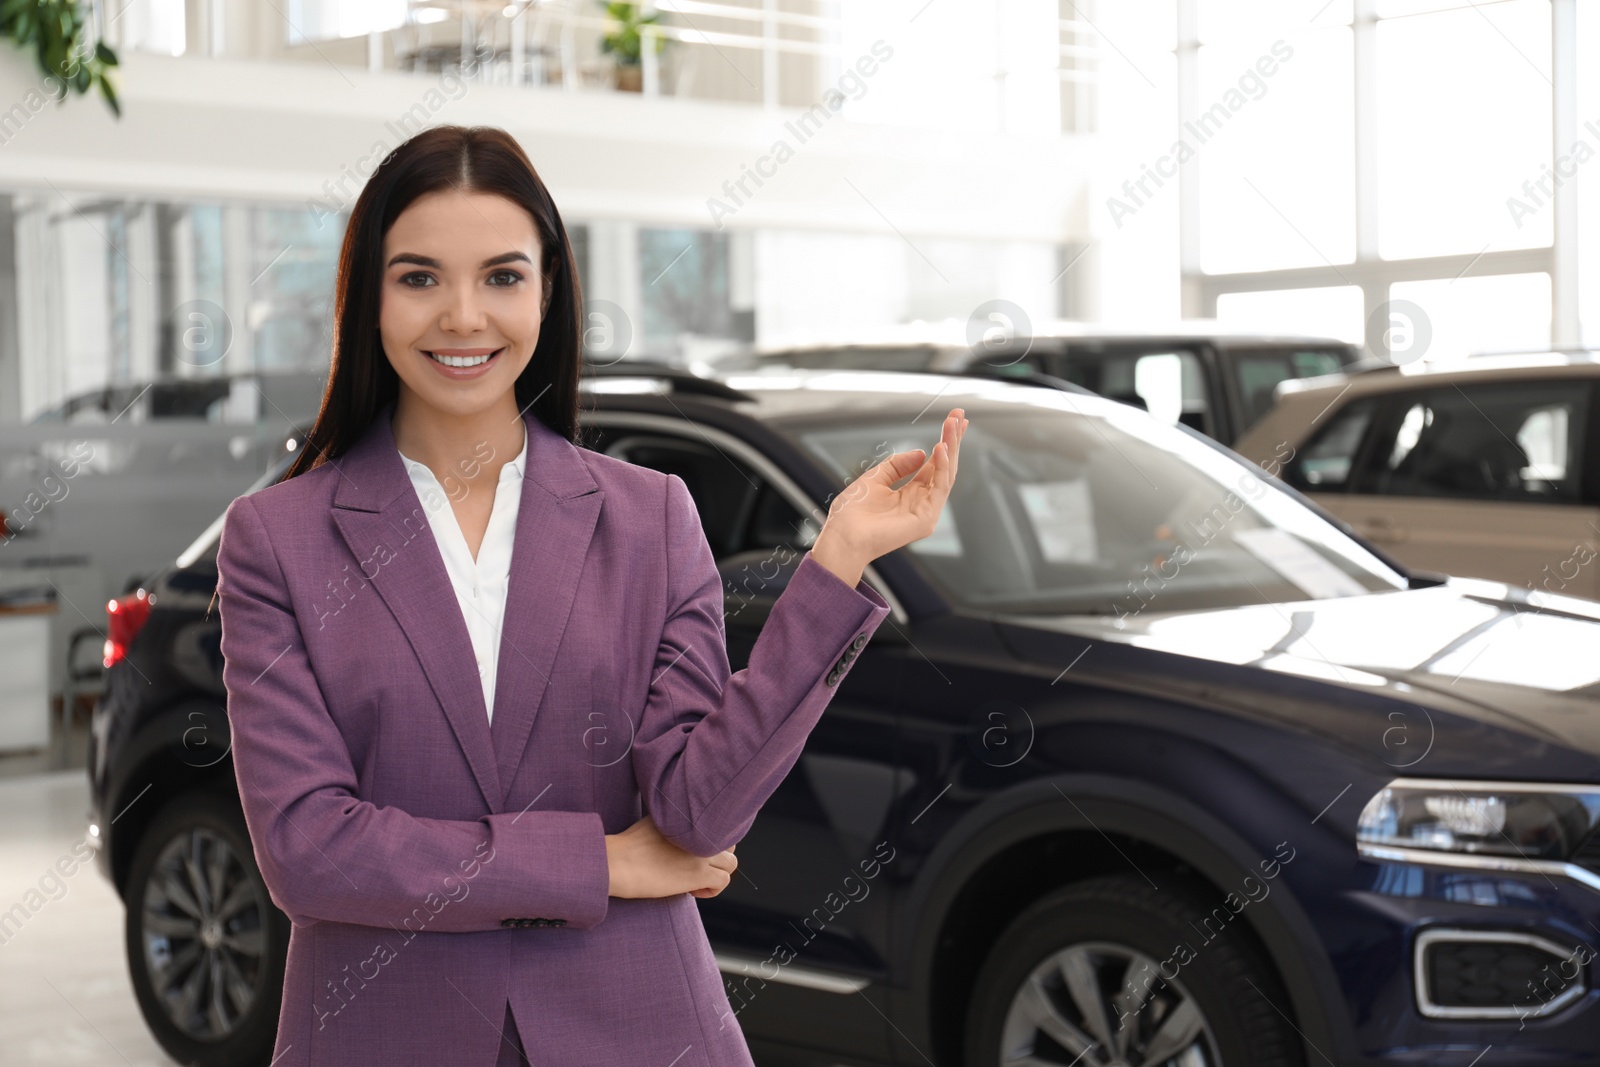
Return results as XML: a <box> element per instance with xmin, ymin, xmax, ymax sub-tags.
<box><xmin>218</xmin><ymin>126</ymin><xmax>965</xmax><ymax>1067</ymax></box>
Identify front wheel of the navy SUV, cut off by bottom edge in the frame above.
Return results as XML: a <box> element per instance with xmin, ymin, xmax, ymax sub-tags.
<box><xmin>965</xmin><ymin>877</ymin><xmax>1302</xmax><ymax>1067</ymax></box>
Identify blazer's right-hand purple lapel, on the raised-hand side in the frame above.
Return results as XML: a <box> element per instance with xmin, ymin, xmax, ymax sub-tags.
<box><xmin>480</xmin><ymin>411</ymin><xmax>605</xmax><ymax>789</ymax></box>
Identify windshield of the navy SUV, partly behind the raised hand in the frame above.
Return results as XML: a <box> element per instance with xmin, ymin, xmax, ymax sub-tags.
<box><xmin>786</xmin><ymin>386</ymin><xmax>1406</xmax><ymax>617</ymax></box>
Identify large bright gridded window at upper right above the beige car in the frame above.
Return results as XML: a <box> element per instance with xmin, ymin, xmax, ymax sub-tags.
<box><xmin>1174</xmin><ymin>0</ymin><xmax>1568</xmax><ymax>363</ymax></box>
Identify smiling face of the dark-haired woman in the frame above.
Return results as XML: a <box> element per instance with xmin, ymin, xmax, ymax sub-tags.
<box><xmin>378</xmin><ymin>190</ymin><xmax>547</xmax><ymax>414</ymax></box>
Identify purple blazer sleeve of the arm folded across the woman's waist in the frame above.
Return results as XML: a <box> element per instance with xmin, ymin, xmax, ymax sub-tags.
<box><xmin>216</xmin><ymin>496</ymin><xmax>610</xmax><ymax>931</ymax></box>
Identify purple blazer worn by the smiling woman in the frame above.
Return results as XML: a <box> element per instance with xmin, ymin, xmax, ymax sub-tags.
<box><xmin>218</xmin><ymin>403</ymin><xmax>890</xmax><ymax>1067</ymax></box>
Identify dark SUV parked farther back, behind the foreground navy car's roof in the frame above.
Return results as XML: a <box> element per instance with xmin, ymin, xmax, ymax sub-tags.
<box><xmin>709</xmin><ymin>321</ymin><xmax>1369</xmax><ymax>445</ymax></box>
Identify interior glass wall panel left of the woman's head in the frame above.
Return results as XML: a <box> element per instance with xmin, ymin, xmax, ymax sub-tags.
<box><xmin>11</xmin><ymin>190</ymin><xmax>344</xmax><ymax>422</ymax></box>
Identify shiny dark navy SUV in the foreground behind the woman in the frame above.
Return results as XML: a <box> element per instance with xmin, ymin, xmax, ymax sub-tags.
<box><xmin>91</xmin><ymin>368</ymin><xmax>1600</xmax><ymax>1067</ymax></box>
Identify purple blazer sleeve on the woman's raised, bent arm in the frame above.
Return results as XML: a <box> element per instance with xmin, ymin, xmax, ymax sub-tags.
<box><xmin>630</xmin><ymin>475</ymin><xmax>890</xmax><ymax>856</ymax></box>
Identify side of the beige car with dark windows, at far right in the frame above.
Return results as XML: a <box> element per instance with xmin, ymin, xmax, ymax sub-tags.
<box><xmin>1286</xmin><ymin>379</ymin><xmax>1600</xmax><ymax>598</ymax></box>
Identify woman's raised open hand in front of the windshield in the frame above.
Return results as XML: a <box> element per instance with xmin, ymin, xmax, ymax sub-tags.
<box><xmin>811</xmin><ymin>408</ymin><xmax>966</xmax><ymax>587</ymax></box>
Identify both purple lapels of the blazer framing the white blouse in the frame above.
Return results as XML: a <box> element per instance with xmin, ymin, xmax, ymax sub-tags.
<box><xmin>330</xmin><ymin>402</ymin><xmax>605</xmax><ymax>811</ymax></box>
